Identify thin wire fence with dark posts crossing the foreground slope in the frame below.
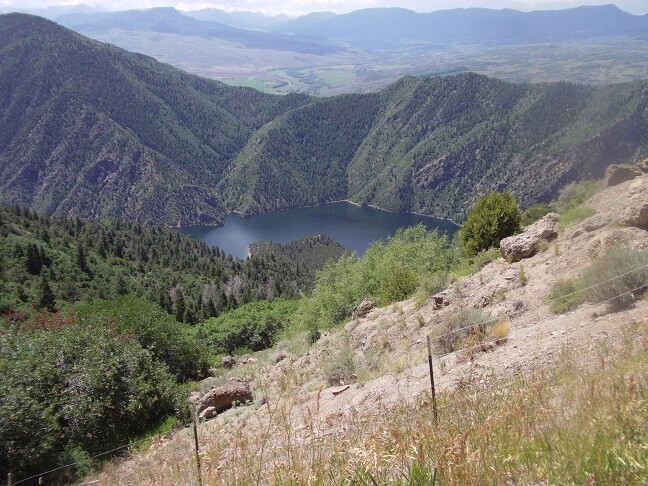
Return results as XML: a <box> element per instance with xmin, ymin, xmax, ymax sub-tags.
<box><xmin>7</xmin><ymin>264</ymin><xmax>648</xmax><ymax>486</ymax></box>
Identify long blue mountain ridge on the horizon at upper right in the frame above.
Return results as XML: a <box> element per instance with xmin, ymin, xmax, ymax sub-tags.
<box><xmin>273</xmin><ymin>5</ymin><xmax>648</xmax><ymax>47</ymax></box>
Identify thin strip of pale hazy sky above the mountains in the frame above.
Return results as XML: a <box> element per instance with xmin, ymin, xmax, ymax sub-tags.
<box><xmin>0</xmin><ymin>0</ymin><xmax>648</xmax><ymax>16</ymax></box>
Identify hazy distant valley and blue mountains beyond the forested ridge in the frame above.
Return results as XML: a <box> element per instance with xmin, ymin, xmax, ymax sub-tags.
<box><xmin>12</xmin><ymin>6</ymin><xmax>648</xmax><ymax>96</ymax></box>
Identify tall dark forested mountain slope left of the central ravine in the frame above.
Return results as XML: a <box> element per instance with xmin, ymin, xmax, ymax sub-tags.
<box><xmin>0</xmin><ymin>14</ymin><xmax>305</xmax><ymax>224</ymax></box>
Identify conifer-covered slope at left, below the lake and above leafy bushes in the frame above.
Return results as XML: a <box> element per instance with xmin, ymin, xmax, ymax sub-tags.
<box><xmin>0</xmin><ymin>207</ymin><xmax>312</xmax><ymax>324</ymax></box>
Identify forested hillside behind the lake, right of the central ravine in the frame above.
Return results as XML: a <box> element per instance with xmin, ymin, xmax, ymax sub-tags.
<box><xmin>227</xmin><ymin>74</ymin><xmax>648</xmax><ymax>220</ymax></box>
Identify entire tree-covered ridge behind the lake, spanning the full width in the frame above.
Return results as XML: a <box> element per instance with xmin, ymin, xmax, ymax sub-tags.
<box><xmin>0</xmin><ymin>14</ymin><xmax>648</xmax><ymax>225</ymax></box>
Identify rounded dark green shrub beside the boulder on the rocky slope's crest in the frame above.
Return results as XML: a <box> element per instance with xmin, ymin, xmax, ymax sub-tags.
<box><xmin>457</xmin><ymin>191</ymin><xmax>522</xmax><ymax>257</ymax></box>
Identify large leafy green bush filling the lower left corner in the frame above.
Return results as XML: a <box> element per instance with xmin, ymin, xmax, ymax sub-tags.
<box><xmin>0</xmin><ymin>314</ymin><xmax>180</xmax><ymax>484</ymax></box>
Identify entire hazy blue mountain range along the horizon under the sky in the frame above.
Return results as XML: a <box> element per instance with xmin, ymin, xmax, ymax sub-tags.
<box><xmin>36</xmin><ymin>5</ymin><xmax>648</xmax><ymax>52</ymax></box>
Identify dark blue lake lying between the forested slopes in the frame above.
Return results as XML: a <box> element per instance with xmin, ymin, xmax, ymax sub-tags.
<box><xmin>180</xmin><ymin>202</ymin><xmax>458</xmax><ymax>258</ymax></box>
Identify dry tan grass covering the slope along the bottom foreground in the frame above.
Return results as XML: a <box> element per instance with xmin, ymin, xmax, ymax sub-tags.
<box><xmin>95</xmin><ymin>321</ymin><xmax>648</xmax><ymax>485</ymax></box>
